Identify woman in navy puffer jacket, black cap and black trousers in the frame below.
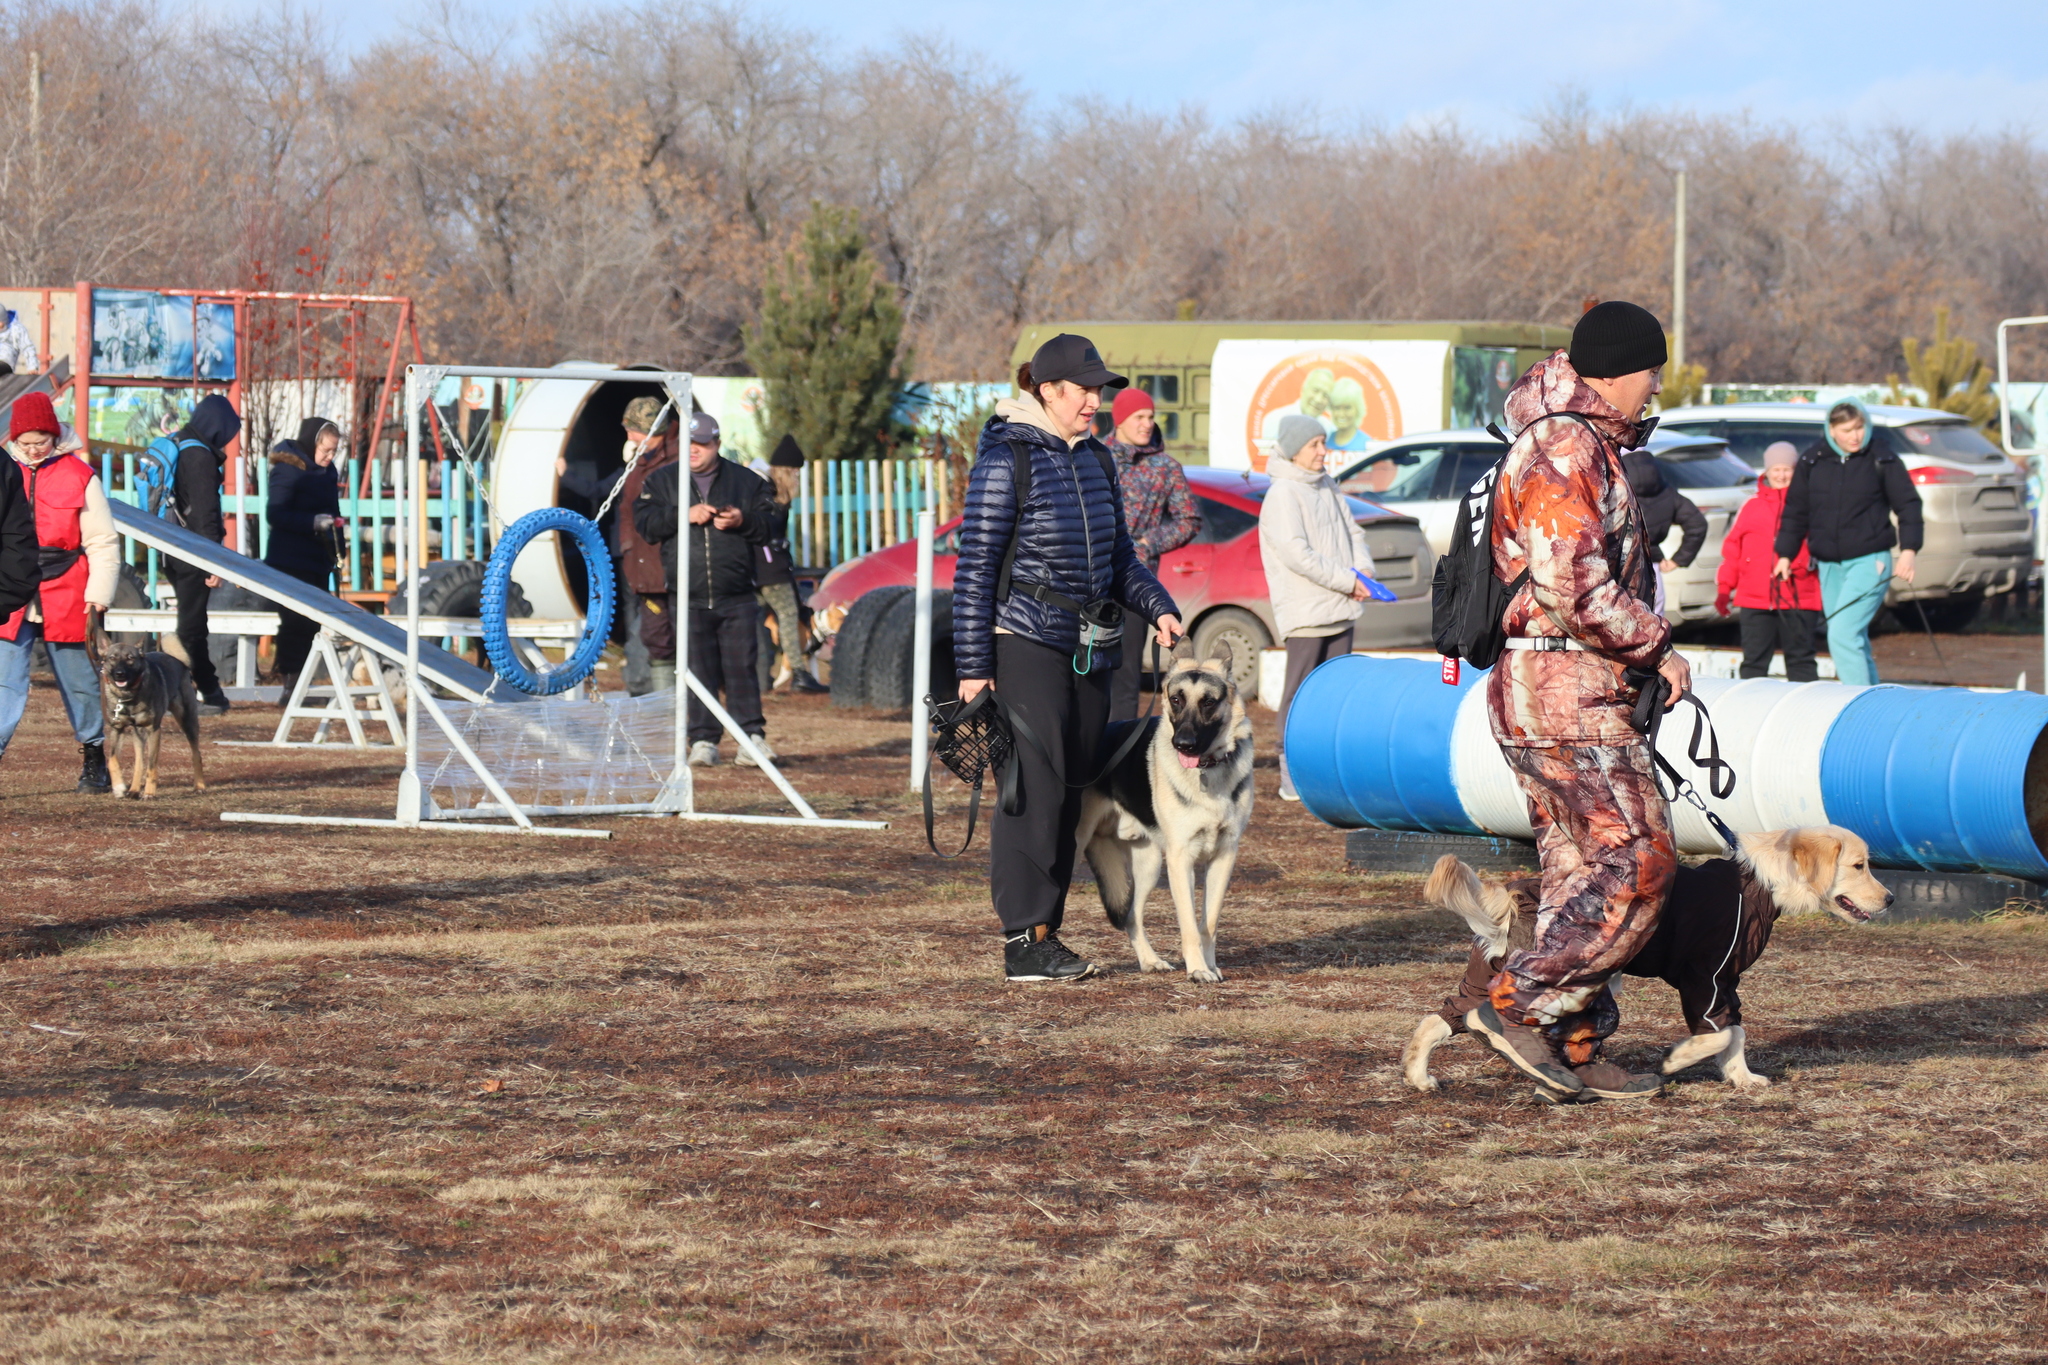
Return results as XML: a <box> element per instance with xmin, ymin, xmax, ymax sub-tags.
<box><xmin>952</xmin><ymin>334</ymin><xmax>1180</xmax><ymax>980</ymax></box>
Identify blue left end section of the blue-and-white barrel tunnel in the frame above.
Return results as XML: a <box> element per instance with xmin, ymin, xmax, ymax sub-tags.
<box><xmin>1286</xmin><ymin>655</ymin><xmax>1485</xmax><ymax>835</ymax></box>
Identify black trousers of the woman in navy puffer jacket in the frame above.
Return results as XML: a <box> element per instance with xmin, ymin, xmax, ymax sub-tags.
<box><xmin>989</xmin><ymin>634</ymin><xmax>1110</xmax><ymax>933</ymax></box>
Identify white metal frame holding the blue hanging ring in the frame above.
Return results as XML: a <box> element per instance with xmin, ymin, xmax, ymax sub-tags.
<box><xmin>221</xmin><ymin>364</ymin><xmax>889</xmax><ymax>839</ymax></box>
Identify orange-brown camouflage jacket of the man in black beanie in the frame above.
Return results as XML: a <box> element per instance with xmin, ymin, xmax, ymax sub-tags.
<box><xmin>1487</xmin><ymin>352</ymin><xmax>1671</xmax><ymax>747</ymax></box>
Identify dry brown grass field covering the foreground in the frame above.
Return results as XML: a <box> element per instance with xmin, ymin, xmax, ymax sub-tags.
<box><xmin>0</xmin><ymin>688</ymin><xmax>2048</xmax><ymax>1365</ymax></box>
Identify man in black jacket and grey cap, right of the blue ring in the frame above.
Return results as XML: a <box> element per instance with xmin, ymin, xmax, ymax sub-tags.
<box><xmin>633</xmin><ymin>413</ymin><xmax>774</xmax><ymax>767</ymax></box>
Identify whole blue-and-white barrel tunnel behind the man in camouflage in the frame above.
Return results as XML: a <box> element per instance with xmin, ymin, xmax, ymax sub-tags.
<box><xmin>1286</xmin><ymin>655</ymin><xmax>2048</xmax><ymax>880</ymax></box>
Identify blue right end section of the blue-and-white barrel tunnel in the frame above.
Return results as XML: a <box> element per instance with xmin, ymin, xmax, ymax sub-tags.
<box><xmin>1821</xmin><ymin>686</ymin><xmax>2048</xmax><ymax>878</ymax></box>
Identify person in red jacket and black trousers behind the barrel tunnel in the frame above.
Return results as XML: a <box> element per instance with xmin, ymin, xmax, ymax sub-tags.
<box><xmin>1714</xmin><ymin>440</ymin><xmax>1823</xmax><ymax>681</ymax></box>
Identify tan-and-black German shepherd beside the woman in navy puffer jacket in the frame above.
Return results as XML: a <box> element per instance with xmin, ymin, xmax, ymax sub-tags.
<box><xmin>1075</xmin><ymin>641</ymin><xmax>1251</xmax><ymax>980</ymax></box>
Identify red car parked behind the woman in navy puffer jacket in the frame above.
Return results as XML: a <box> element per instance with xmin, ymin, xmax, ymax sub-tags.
<box><xmin>811</xmin><ymin>467</ymin><xmax>1436</xmax><ymax>706</ymax></box>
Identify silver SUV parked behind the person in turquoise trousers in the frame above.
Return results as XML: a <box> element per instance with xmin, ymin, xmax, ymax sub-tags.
<box><xmin>1663</xmin><ymin>403</ymin><xmax>2034</xmax><ymax>630</ymax></box>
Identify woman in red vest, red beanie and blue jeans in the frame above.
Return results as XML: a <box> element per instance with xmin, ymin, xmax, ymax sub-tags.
<box><xmin>0</xmin><ymin>393</ymin><xmax>121</xmax><ymax>792</ymax></box>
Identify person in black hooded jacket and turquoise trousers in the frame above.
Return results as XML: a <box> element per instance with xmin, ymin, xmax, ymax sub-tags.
<box><xmin>1772</xmin><ymin>399</ymin><xmax>1923</xmax><ymax>686</ymax></box>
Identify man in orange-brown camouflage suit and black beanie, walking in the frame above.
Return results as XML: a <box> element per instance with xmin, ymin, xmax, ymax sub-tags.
<box><xmin>1466</xmin><ymin>303</ymin><xmax>1692</xmax><ymax>1099</ymax></box>
